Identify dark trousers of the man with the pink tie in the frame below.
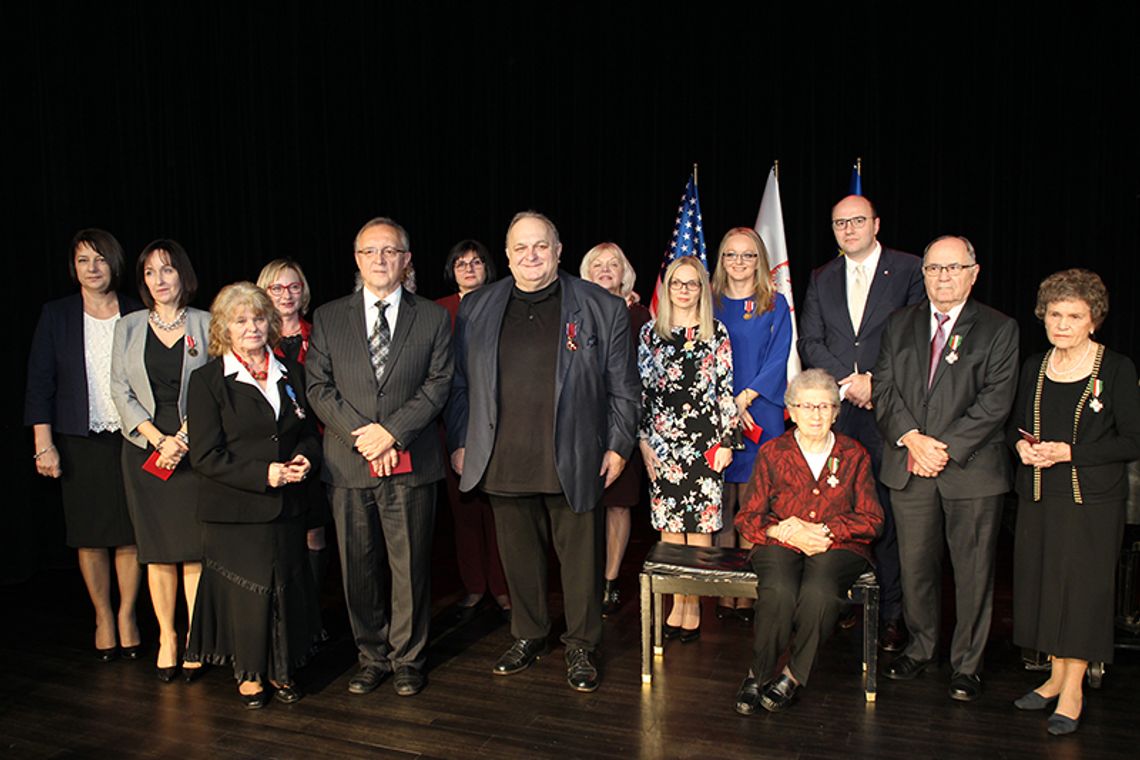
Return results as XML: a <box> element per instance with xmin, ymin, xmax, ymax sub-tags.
<box><xmin>891</xmin><ymin>477</ymin><xmax>1004</xmax><ymax>675</ymax></box>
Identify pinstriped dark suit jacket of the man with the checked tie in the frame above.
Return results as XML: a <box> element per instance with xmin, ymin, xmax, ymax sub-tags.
<box><xmin>304</xmin><ymin>291</ymin><xmax>453</xmax><ymax>488</ymax></box>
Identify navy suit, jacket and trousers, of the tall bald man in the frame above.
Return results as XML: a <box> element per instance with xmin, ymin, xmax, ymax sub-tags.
<box><xmin>796</xmin><ymin>248</ymin><xmax>926</xmax><ymax>621</ymax></box>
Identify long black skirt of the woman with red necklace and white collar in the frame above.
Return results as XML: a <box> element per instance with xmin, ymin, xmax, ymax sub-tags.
<box><xmin>186</xmin><ymin>515</ymin><xmax>321</xmax><ymax>684</ymax></box>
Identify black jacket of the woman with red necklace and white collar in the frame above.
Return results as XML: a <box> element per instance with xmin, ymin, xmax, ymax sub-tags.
<box><xmin>187</xmin><ymin>357</ymin><xmax>320</xmax><ymax>523</ymax></box>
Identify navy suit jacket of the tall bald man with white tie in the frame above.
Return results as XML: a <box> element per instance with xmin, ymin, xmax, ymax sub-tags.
<box><xmin>796</xmin><ymin>247</ymin><xmax>926</xmax><ymax>381</ymax></box>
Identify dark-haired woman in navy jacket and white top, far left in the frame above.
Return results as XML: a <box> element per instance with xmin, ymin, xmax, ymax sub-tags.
<box><xmin>24</xmin><ymin>229</ymin><xmax>143</xmax><ymax>662</ymax></box>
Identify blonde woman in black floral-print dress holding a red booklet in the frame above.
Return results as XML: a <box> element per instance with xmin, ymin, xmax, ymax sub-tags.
<box><xmin>637</xmin><ymin>256</ymin><xmax>740</xmax><ymax>644</ymax></box>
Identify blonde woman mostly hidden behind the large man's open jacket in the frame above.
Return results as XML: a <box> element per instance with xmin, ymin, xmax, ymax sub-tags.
<box><xmin>579</xmin><ymin>243</ymin><xmax>650</xmax><ymax>615</ymax></box>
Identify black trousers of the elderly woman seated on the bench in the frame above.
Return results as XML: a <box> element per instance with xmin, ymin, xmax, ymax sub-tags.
<box><xmin>751</xmin><ymin>545</ymin><xmax>868</xmax><ymax>685</ymax></box>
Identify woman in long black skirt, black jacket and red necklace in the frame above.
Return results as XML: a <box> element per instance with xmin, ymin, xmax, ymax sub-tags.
<box><xmin>186</xmin><ymin>283</ymin><xmax>320</xmax><ymax>709</ymax></box>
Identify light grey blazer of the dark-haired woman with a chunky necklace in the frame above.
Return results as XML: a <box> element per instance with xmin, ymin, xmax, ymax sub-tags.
<box><xmin>111</xmin><ymin>309</ymin><xmax>210</xmax><ymax>449</ymax></box>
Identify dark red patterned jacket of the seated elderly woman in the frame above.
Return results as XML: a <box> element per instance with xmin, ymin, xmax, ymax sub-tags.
<box><xmin>736</xmin><ymin>431</ymin><xmax>882</xmax><ymax>562</ymax></box>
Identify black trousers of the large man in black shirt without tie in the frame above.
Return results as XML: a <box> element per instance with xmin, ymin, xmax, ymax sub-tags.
<box><xmin>490</xmin><ymin>493</ymin><xmax>602</xmax><ymax>652</ymax></box>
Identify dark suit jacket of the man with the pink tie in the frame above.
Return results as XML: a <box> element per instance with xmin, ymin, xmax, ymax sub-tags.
<box><xmin>871</xmin><ymin>299</ymin><xmax>1018</xmax><ymax>499</ymax></box>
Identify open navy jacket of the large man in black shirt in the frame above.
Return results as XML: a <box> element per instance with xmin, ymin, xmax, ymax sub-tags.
<box><xmin>446</xmin><ymin>272</ymin><xmax>641</xmax><ymax>513</ymax></box>
